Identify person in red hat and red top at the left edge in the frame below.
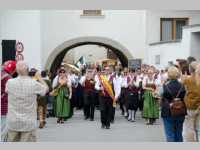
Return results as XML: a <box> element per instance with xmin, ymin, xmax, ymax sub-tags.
<box><xmin>1</xmin><ymin>60</ymin><xmax>16</xmax><ymax>139</ymax></box>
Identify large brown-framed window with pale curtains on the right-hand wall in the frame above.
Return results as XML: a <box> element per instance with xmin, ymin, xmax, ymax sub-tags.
<box><xmin>160</xmin><ymin>18</ymin><xmax>188</xmax><ymax>41</ymax></box>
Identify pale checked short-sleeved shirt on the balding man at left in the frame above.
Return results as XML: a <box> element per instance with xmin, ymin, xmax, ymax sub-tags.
<box><xmin>6</xmin><ymin>76</ymin><xmax>48</xmax><ymax>132</ymax></box>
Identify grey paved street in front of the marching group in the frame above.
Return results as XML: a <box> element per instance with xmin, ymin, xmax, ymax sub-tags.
<box><xmin>38</xmin><ymin>110</ymin><xmax>165</xmax><ymax>142</ymax></box>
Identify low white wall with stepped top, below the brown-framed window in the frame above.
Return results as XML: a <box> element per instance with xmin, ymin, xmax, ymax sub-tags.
<box><xmin>148</xmin><ymin>26</ymin><xmax>200</xmax><ymax>68</ymax></box>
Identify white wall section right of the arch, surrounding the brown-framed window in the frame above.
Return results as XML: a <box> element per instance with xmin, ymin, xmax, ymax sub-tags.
<box><xmin>146</xmin><ymin>11</ymin><xmax>200</xmax><ymax>69</ymax></box>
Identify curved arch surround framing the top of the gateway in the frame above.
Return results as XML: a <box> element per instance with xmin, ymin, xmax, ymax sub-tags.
<box><xmin>45</xmin><ymin>36</ymin><xmax>133</xmax><ymax>75</ymax></box>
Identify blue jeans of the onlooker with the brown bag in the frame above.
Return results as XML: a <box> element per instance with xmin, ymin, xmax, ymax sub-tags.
<box><xmin>163</xmin><ymin>117</ymin><xmax>185</xmax><ymax>142</ymax></box>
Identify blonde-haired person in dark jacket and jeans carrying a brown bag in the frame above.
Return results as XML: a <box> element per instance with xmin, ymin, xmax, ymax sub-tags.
<box><xmin>161</xmin><ymin>66</ymin><xmax>186</xmax><ymax>142</ymax></box>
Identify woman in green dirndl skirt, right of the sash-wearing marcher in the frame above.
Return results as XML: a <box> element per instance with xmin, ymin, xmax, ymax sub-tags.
<box><xmin>143</xmin><ymin>69</ymin><xmax>159</xmax><ymax>125</ymax></box>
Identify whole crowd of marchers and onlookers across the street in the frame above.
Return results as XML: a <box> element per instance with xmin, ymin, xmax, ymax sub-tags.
<box><xmin>1</xmin><ymin>57</ymin><xmax>200</xmax><ymax>142</ymax></box>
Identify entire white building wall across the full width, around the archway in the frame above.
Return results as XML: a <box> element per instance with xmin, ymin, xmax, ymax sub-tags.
<box><xmin>0</xmin><ymin>10</ymin><xmax>200</xmax><ymax>69</ymax></box>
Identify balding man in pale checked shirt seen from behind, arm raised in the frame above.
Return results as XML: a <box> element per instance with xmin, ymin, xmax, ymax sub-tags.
<box><xmin>6</xmin><ymin>61</ymin><xmax>48</xmax><ymax>142</ymax></box>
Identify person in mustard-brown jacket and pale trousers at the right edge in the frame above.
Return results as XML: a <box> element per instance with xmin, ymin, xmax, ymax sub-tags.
<box><xmin>182</xmin><ymin>61</ymin><xmax>200</xmax><ymax>142</ymax></box>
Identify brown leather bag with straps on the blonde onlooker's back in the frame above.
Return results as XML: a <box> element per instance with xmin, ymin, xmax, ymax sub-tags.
<box><xmin>166</xmin><ymin>86</ymin><xmax>187</xmax><ymax>117</ymax></box>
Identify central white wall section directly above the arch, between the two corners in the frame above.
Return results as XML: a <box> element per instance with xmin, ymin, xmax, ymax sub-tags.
<box><xmin>41</xmin><ymin>10</ymin><xmax>145</xmax><ymax>69</ymax></box>
